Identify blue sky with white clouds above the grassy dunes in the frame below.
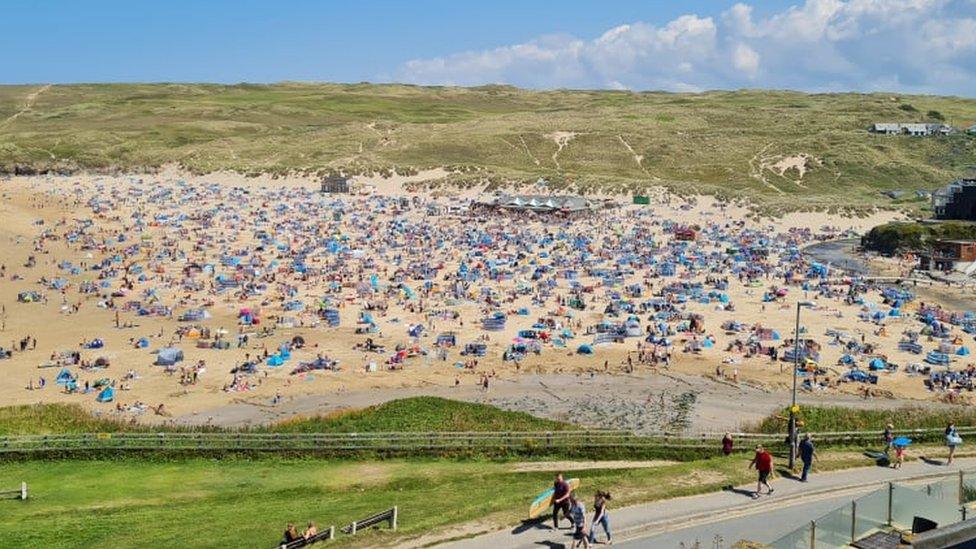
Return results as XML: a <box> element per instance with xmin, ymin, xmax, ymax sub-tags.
<box><xmin>0</xmin><ymin>0</ymin><xmax>976</xmax><ymax>97</ymax></box>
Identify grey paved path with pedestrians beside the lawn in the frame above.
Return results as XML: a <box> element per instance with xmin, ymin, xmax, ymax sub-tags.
<box><xmin>447</xmin><ymin>458</ymin><xmax>976</xmax><ymax>549</ymax></box>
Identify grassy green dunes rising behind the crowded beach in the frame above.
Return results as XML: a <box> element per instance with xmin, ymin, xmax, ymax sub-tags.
<box><xmin>0</xmin><ymin>83</ymin><xmax>976</xmax><ymax>207</ymax></box>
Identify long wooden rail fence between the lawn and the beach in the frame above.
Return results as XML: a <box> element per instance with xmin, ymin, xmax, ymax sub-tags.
<box><xmin>0</xmin><ymin>427</ymin><xmax>976</xmax><ymax>455</ymax></box>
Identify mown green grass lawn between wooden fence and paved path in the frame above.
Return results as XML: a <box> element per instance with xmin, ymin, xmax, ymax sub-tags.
<box><xmin>0</xmin><ymin>449</ymin><xmax>952</xmax><ymax>547</ymax></box>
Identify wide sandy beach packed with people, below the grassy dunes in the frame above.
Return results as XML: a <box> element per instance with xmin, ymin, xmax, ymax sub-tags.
<box><xmin>0</xmin><ymin>168</ymin><xmax>976</xmax><ymax>431</ymax></box>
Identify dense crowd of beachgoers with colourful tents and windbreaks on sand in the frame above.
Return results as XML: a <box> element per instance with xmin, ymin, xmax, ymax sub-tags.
<box><xmin>0</xmin><ymin>171</ymin><xmax>976</xmax><ymax>424</ymax></box>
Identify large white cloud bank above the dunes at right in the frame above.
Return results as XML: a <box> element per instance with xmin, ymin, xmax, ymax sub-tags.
<box><xmin>397</xmin><ymin>0</ymin><xmax>976</xmax><ymax>96</ymax></box>
